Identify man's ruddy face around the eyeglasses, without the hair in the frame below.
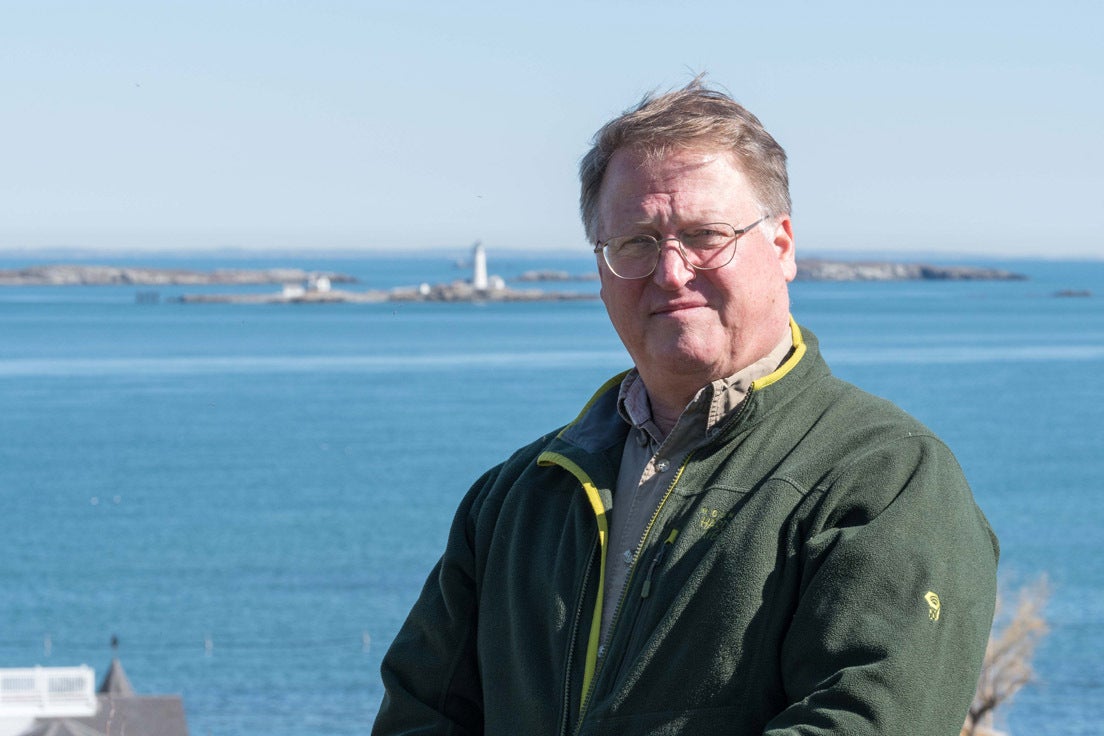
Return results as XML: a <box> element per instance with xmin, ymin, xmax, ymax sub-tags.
<box><xmin>598</xmin><ymin>149</ymin><xmax>796</xmax><ymax>398</ymax></box>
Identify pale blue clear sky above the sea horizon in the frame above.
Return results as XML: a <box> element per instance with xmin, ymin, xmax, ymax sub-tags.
<box><xmin>0</xmin><ymin>0</ymin><xmax>1104</xmax><ymax>257</ymax></box>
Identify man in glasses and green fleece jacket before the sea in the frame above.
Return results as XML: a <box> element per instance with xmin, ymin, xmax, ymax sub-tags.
<box><xmin>373</xmin><ymin>81</ymin><xmax>997</xmax><ymax>736</ymax></box>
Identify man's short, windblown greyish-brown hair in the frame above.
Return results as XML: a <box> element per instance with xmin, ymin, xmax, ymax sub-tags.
<box><xmin>578</xmin><ymin>75</ymin><xmax>790</xmax><ymax>244</ymax></box>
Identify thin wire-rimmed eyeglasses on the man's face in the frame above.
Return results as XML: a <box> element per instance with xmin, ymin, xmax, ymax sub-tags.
<box><xmin>594</xmin><ymin>216</ymin><xmax>766</xmax><ymax>279</ymax></box>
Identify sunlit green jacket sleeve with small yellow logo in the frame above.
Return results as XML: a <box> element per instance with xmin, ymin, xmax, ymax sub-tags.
<box><xmin>766</xmin><ymin>434</ymin><xmax>998</xmax><ymax>736</ymax></box>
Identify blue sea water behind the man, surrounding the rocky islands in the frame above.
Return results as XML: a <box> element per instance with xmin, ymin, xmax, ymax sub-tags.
<box><xmin>0</xmin><ymin>253</ymin><xmax>1104</xmax><ymax>736</ymax></box>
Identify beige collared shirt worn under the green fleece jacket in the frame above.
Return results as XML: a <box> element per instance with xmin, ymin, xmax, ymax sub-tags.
<box><xmin>601</xmin><ymin>328</ymin><xmax>793</xmax><ymax>648</ymax></box>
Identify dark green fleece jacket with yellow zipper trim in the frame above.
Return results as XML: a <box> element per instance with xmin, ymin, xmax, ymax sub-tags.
<box><xmin>373</xmin><ymin>324</ymin><xmax>998</xmax><ymax>736</ymax></box>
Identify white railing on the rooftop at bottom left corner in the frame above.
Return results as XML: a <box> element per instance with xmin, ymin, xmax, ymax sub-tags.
<box><xmin>0</xmin><ymin>664</ymin><xmax>96</xmax><ymax>718</ymax></box>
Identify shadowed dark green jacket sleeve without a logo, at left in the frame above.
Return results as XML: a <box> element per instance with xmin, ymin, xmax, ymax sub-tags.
<box><xmin>372</xmin><ymin>471</ymin><xmax>495</xmax><ymax>736</ymax></box>
